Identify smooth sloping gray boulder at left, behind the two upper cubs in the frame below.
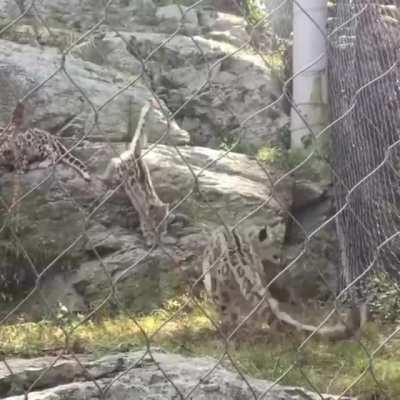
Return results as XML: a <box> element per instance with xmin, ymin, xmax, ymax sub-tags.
<box><xmin>0</xmin><ymin>40</ymin><xmax>189</xmax><ymax>145</ymax></box>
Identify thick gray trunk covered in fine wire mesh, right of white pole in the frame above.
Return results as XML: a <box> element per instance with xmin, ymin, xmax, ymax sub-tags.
<box><xmin>329</xmin><ymin>1</ymin><xmax>400</xmax><ymax>301</ymax></box>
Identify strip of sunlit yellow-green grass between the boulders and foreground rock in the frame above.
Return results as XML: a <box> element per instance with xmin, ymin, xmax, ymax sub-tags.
<box><xmin>0</xmin><ymin>299</ymin><xmax>400</xmax><ymax>400</ymax></box>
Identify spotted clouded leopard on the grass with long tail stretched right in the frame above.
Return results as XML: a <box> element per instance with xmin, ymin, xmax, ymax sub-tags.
<box><xmin>202</xmin><ymin>223</ymin><xmax>354</xmax><ymax>337</ymax></box>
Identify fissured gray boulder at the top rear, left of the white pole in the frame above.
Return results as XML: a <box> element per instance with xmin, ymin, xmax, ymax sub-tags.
<box><xmin>0</xmin><ymin>0</ymin><xmax>289</xmax><ymax>153</ymax></box>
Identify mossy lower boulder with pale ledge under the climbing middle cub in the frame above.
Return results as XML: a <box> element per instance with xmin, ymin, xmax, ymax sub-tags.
<box><xmin>0</xmin><ymin>143</ymin><xmax>291</xmax><ymax>317</ymax></box>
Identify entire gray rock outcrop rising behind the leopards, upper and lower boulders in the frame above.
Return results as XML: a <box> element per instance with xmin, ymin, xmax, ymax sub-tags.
<box><xmin>0</xmin><ymin>0</ymin><xmax>338</xmax><ymax>328</ymax></box>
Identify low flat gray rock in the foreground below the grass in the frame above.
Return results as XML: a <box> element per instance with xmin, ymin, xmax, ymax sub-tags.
<box><xmin>0</xmin><ymin>349</ymin><xmax>349</xmax><ymax>400</ymax></box>
